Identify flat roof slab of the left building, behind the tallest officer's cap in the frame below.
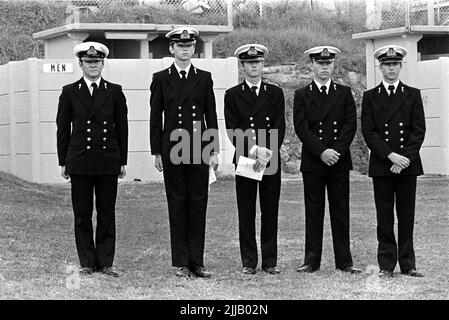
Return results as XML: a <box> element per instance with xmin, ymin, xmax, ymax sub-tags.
<box><xmin>33</xmin><ymin>23</ymin><xmax>234</xmax><ymax>40</ymax></box>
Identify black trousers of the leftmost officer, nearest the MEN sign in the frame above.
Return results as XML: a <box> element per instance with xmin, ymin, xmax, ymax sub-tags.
<box><xmin>70</xmin><ymin>175</ymin><xmax>118</xmax><ymax>268</ymax></box>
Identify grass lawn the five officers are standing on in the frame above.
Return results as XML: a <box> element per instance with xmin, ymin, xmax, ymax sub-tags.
<box><xmin>0</xmin><ymin>172</ymin><xmax>449</xmax><ymax>300</ymax></box>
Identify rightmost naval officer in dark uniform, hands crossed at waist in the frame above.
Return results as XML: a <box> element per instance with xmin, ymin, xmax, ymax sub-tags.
<box><xmin>362</xmin><ymin>45</ymin><xmax>426</xmax><ymax>277</ymax></box>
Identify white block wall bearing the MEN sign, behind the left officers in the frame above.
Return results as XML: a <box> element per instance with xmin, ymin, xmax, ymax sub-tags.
<box><xmin>0</xmin><ymin>58</ymin><xmax>238</xmax><ymax>183</ymax></box>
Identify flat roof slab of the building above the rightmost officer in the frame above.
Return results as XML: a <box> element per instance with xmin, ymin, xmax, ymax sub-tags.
<box><xmin>352</xmin><ymin>26</ymin><xmax>449</xmax><ymax>40</ymax></box>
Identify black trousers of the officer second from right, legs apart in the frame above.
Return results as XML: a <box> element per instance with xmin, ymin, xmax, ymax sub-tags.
<box><xmin>302</xmin><ymin>171</ymin><xmax>352</xmax><ymax>269</ymax></box>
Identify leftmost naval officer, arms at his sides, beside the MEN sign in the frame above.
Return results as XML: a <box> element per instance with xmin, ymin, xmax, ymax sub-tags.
<box><xmin>56</xmin><ymin>42</ymin><xmax>128</xmax><ymax>277</ymax></box>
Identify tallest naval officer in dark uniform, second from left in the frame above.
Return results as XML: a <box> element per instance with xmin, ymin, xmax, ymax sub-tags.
<box><xmin>150</xmin><ymin>27</ymin><xmax>219</xmax><ymax>277</ymax></box>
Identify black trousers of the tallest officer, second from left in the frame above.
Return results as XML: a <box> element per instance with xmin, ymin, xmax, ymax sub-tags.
<box><xmin>163</xmin><ymin>161</ymin><xmax>209</xmax><ymax>268</ymax></box>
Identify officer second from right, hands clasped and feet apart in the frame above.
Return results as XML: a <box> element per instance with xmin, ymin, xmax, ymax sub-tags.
<box><xmin>293</xmin><ymin>46</ymin><xmax>361</xmax><ymax>273</ymax></box>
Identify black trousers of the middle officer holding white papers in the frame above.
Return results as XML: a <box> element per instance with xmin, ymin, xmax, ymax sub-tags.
<box><xmin>235</xmin><ymin>170</ymin><xmax>281</xmax><ymax>268</ymax></box>
